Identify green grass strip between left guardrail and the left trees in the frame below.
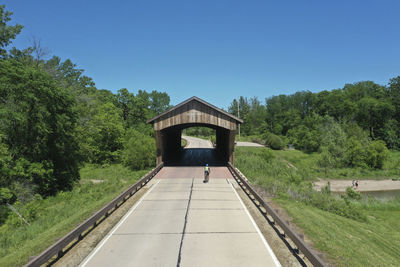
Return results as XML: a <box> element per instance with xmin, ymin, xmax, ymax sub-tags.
<box><xmin>0</xmin><ymin>165</ymin><xmax>148</xmax><ymax>266</ymax></box>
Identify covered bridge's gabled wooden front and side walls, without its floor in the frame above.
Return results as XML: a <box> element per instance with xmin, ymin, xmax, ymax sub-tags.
<box><xmin>147</xmin><ymin>96</ymin><xmax>243</xmax><ymax>164</ymax></box>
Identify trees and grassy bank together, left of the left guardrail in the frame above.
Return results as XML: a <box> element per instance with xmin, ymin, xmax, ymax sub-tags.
<box><xmin>0</xmin><ymin>5</ymin><xmax>162</xmax><ymax>266</ymax></box>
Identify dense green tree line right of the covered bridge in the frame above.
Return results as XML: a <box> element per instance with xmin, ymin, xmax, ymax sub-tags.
<box><xmin>228</xmin><ymin>76</ymin><xmax>400</xmax><ymax>168</ymax></box>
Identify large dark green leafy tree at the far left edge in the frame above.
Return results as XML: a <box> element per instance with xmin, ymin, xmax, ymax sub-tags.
<box><xmin>0</xmin><ymin>60</ymin><xmax>79</xmax><ymax>195</ymax></box>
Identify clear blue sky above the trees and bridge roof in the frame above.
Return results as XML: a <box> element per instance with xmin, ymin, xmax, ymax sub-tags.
<box><xmin>0</xmin><ymin>0</ymin><xmax>400</xmax><ymax>108</ymax></box>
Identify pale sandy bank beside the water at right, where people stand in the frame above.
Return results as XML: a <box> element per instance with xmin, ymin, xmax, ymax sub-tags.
<box><xmin>314</xmin><ymin>179</ymin><xmax>400</xmax><ymax>192</ymax></box>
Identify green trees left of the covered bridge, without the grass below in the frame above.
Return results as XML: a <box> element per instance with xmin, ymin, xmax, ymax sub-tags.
<box><xmin>0</xmin><ymin>5</ymin><xmax>170</xmax><ymax>217</ymax></box>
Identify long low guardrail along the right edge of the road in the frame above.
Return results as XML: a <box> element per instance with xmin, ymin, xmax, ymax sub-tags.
<box><xmin>228</xmin><ymin>162</ymin><xmax>328</xmax><ymax>267</ymax></box>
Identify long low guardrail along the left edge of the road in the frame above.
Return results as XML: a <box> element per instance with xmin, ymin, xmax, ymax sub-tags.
<box><xmin>25</xmin><ymin>163</ymin><xmax>163</xmax><ymax>267</ymax></box>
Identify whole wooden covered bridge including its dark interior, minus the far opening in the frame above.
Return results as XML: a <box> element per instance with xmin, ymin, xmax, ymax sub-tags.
<box><xmin>148</xmin><ymin>97</ymin><xmax>242</xmax><ymax>166</ymax></box>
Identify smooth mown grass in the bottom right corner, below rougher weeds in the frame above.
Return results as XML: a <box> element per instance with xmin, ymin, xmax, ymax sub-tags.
<box><xmin>277</xmin><ymin>200</ymin><xmax>400</xmax><ymax>266</ymax></box>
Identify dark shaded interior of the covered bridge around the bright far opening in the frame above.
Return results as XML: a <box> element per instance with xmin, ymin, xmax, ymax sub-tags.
<box><xmin>161</xmin><ymin>124</ymin><xmax>230</xmax><ymax>166</ymax></box>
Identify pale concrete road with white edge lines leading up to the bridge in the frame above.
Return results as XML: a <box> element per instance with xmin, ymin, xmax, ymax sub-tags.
<box><xmin>81</xmin><ymin>167</ymin><xmax>280</xmax><ymax>267</ymax></box>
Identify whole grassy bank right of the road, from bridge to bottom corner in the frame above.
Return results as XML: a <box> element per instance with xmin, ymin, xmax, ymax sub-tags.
<box><xmin>235</xmin><ymin>147</ymin><xmax>400</xmax><ymax>266</ymax></box>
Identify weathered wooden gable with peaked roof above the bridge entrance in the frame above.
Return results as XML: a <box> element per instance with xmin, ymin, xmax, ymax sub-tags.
<box><xmin>148</xmin><ymin>97</ymin><xmax>243</xmax><ymax>131</ymax></box>
